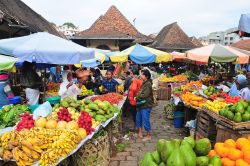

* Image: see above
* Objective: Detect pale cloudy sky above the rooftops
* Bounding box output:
[22,0,250,37]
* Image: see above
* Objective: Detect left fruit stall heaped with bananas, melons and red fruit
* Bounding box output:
[0,93,125,165]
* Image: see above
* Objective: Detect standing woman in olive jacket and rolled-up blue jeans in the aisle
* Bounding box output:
[136,70,154,141]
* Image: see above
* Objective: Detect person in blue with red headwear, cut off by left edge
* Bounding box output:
[0,72,14,109]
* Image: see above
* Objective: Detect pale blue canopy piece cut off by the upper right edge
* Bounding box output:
[238,14,250,37]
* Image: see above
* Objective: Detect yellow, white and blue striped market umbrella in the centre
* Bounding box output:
[110,44,172,64]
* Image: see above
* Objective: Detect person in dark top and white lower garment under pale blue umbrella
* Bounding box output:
[20,62,42,105]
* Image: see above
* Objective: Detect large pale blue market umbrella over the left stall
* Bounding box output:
[0,32,94,65]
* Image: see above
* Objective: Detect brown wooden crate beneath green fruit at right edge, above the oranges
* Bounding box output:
[216,124,250,142]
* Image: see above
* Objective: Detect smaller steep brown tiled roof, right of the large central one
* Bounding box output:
[151,22,196,50]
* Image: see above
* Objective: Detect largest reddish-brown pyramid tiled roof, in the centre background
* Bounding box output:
[76,6,151,41]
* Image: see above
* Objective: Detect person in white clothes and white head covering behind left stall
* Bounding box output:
[58,71,79,99]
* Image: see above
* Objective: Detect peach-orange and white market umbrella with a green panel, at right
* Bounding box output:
[186,44,249,63]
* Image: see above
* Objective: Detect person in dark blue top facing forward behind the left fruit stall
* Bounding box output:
[102,70,119,93]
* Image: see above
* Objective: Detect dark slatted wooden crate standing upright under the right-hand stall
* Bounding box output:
[196,110,217,143]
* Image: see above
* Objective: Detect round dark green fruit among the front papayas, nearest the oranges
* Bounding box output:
[194,138,211,156]
